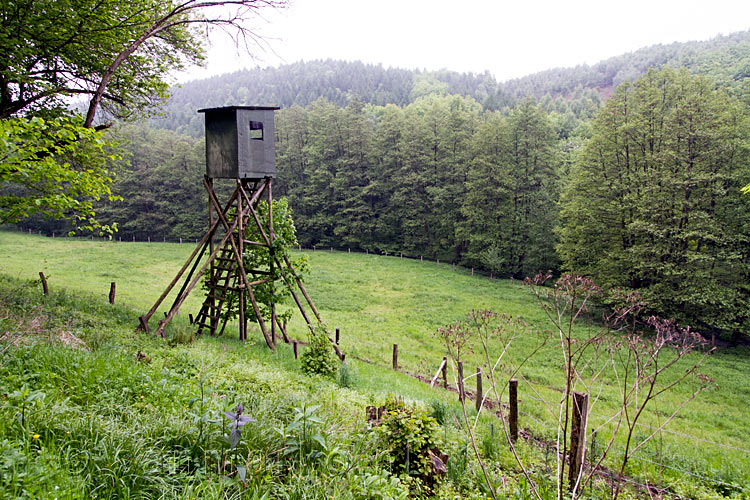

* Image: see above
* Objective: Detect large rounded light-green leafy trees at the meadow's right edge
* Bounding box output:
[559,66,750,331]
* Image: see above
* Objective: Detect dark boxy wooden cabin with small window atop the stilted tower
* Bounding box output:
[198,106,279,179]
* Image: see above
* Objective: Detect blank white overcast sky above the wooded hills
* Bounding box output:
[175,0,750,82]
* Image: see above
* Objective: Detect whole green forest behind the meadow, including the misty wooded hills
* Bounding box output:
[16,32,750,341]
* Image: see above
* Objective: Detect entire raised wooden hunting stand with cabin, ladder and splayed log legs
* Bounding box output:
[139,106,343,359]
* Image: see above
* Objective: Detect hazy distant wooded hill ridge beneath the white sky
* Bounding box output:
[151,31,750,137]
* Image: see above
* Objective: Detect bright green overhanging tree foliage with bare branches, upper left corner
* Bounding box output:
[0,0,285,228]
